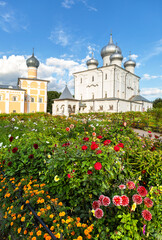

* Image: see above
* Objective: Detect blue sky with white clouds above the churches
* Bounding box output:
[0,0,162,100]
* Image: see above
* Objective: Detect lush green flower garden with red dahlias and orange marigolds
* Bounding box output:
[0,113,162,240]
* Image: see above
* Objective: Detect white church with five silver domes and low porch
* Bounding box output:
[52,34,152,116]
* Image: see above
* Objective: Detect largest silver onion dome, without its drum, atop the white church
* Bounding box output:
[101,34,121,58]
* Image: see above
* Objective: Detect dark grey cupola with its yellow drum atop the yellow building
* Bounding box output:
[26,50,39,78]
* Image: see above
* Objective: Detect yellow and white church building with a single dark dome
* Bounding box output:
[0,53,49,113]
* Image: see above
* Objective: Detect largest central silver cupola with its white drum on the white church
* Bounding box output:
[101,33,121,66]
